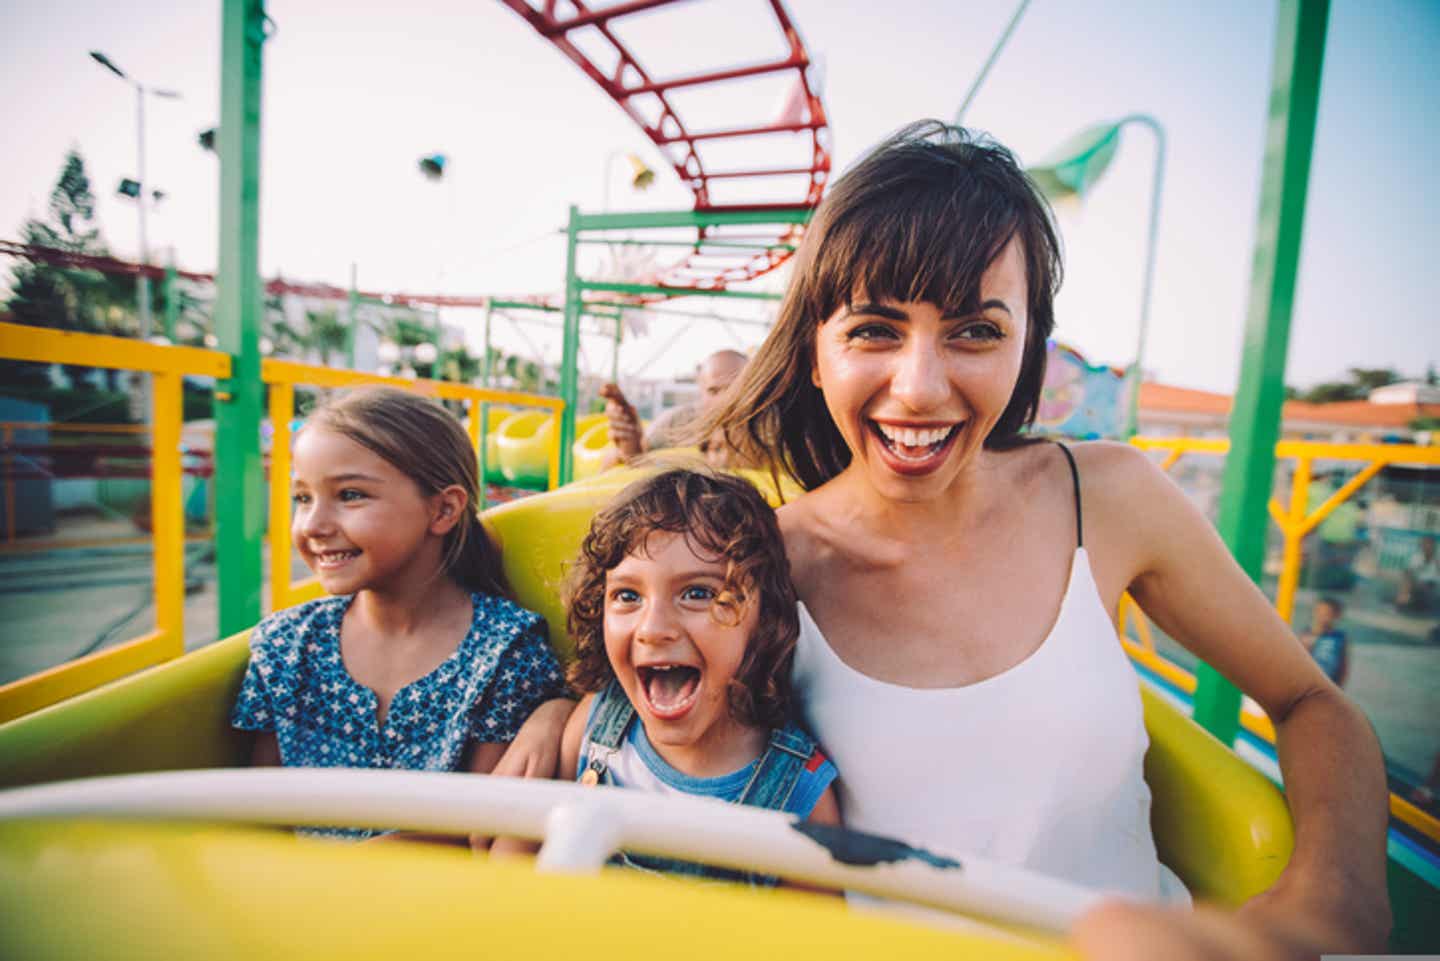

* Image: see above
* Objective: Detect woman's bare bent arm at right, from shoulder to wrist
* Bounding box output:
[1081,445,1391,952]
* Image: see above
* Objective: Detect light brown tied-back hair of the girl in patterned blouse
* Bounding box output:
[307,386,510,598]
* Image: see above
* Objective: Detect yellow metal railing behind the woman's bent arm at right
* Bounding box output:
[1116,437,1440,841]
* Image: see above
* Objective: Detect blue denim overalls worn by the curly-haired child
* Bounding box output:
[585,680,818,888]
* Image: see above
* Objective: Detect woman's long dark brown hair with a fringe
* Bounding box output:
[696,120,1061,490]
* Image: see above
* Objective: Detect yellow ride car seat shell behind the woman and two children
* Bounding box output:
[0,468,1293,905]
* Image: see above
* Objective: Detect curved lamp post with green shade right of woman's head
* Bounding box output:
[1030,114,1165,437]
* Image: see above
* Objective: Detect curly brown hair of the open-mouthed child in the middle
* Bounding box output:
[566,468,799,728]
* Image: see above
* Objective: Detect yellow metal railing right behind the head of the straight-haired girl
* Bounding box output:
[261,360,564,611]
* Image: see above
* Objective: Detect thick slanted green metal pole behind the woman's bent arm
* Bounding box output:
[1195,0,1329,743]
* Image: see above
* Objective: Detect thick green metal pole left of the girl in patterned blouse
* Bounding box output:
[215,0,269,637]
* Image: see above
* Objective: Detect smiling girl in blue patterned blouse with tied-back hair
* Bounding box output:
[232,388,564,844]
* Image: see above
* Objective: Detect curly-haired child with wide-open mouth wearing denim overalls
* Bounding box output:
[560,470,840,886]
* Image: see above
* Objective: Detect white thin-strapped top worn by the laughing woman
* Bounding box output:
[793,547,1187,899]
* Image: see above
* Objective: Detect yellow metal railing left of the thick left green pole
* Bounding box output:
[0,323,230,722]
